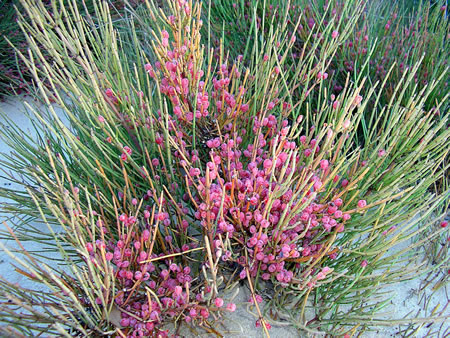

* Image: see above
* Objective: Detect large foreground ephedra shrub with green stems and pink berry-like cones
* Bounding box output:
[0,0,449,337]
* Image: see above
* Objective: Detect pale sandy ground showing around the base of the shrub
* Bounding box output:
[0,97,450,338]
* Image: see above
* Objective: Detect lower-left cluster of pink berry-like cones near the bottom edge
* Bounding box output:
[82,213,236,337]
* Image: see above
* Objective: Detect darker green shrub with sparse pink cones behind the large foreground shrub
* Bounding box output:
[205,0,449,130]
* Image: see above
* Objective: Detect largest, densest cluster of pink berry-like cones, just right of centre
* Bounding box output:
[186,115,356,286]
